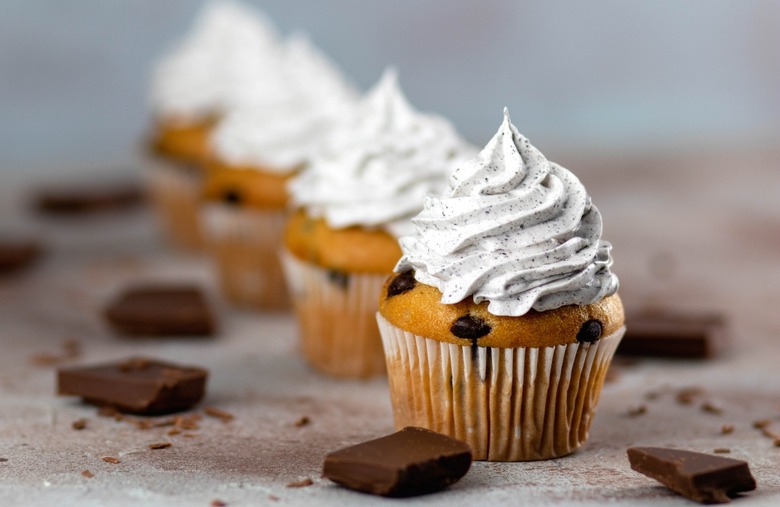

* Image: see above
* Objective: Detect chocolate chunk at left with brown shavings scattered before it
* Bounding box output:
[57,358,208,414]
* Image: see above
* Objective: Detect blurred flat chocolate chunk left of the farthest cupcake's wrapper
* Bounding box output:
[35,180,143,215]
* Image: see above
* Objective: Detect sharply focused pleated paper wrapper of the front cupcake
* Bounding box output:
[377,314,625,461]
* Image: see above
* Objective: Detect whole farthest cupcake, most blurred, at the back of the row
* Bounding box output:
[145,0,279,249]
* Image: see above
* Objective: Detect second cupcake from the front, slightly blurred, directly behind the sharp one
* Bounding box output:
[282,71,473,378]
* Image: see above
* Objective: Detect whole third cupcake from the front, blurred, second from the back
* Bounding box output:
[202,36,358,310]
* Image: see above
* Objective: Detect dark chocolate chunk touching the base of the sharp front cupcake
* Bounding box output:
[322,426,471,497]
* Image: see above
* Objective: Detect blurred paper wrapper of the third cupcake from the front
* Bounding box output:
[201,203,290,310]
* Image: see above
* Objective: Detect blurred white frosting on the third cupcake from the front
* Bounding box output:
[212,36,358,172]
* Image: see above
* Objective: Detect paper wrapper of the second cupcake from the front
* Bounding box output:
[282,251,390,378]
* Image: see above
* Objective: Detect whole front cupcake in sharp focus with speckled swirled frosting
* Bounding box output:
[377,110,625,461]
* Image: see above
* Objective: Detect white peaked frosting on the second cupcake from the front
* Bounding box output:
[290,70,476,236]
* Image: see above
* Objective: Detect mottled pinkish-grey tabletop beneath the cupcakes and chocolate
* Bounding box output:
[0,154,780,506]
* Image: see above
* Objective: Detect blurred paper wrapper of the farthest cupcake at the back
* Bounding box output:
[144,155,204,250]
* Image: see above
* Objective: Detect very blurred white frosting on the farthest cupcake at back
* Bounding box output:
[151,0,280,121]
